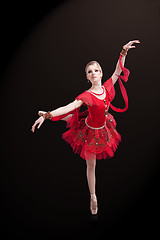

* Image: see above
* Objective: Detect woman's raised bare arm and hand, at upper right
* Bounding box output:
[111,40,140,84]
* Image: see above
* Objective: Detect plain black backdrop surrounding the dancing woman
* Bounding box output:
[0,0,160,239]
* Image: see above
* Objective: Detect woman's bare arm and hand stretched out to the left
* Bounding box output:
[31,99,83,132]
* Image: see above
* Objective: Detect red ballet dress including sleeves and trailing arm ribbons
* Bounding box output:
[51,55,130,160]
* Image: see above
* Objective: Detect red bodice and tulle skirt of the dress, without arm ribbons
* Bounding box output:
[63,88,121,160]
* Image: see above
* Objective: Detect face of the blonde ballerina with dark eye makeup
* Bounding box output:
[86,64,102,83]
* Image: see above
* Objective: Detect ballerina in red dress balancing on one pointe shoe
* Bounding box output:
[31,40,140,215]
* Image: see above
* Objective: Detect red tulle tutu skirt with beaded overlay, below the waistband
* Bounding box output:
[62,113,121,160]
